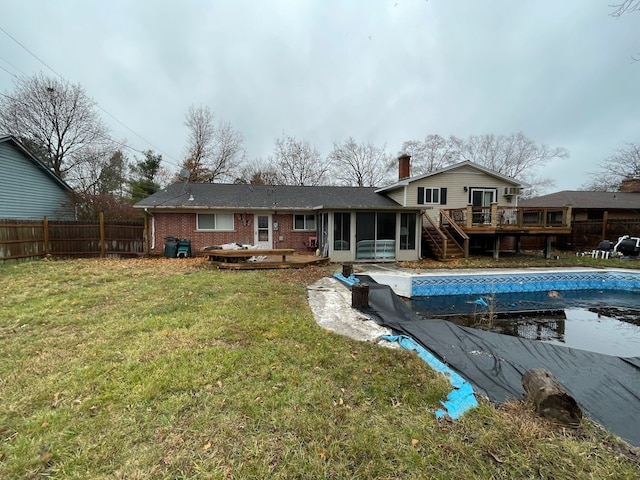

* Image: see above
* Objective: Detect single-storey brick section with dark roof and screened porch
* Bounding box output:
[135,183,420,261]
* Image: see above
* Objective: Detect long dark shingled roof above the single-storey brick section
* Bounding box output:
[134,183,402,210]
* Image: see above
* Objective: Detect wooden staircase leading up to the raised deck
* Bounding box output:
[422,210,469,261]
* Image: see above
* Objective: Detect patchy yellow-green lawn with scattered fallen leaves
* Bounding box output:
[0,259,640,479]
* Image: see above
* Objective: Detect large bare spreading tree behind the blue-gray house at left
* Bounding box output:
[0,73,116,182]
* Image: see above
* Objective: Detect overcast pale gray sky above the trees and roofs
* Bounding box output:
[0,0,640,190]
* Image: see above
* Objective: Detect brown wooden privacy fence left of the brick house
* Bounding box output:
[0,215,145,260]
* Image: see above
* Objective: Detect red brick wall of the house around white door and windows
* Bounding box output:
[148,213,316,255]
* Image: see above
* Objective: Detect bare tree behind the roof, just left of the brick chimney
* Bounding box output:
[329,137,391,187]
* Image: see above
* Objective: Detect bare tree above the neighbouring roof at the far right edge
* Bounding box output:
[582,143,640,192]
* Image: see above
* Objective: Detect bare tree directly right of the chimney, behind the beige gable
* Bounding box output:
[402,135,462,175]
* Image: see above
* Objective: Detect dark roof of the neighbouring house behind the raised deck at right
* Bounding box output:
[518,190,640,210]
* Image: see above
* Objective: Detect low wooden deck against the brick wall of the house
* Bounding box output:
[200,248,329,270]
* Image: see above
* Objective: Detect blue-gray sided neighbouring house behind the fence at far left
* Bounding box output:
[0,135,74,220]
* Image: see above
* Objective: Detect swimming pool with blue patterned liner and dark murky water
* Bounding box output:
[368,268,640,356]
